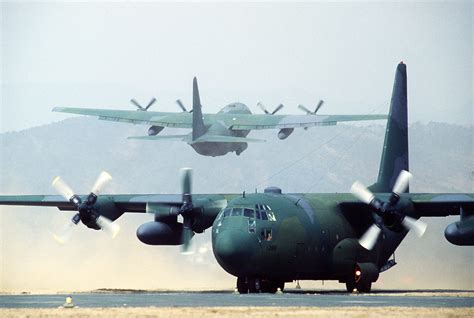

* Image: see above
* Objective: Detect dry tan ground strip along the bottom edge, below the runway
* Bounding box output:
[0,307,474,318]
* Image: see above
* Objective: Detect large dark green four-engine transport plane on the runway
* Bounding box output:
[0,63,474,293]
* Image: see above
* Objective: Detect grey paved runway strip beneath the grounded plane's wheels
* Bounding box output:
[0,291,474,308]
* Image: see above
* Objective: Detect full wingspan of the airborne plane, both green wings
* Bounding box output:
[53,107,387,131]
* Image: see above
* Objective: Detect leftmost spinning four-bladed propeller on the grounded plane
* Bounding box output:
[52,171,120,243]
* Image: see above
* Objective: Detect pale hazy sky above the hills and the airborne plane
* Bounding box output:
[0,1,473,132]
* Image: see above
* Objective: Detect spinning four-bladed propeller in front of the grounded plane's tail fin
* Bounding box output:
[351,170,426,250]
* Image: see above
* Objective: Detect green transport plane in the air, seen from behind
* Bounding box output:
[53,78,387,157]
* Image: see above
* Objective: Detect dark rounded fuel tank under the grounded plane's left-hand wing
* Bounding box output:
[137,221,183,245]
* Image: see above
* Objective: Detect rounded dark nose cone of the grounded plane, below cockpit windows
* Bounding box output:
[213,230,254,272]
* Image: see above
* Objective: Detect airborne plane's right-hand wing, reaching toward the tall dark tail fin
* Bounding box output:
[224,114,387,130]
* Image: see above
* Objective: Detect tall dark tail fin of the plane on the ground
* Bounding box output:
[370,62,409,192]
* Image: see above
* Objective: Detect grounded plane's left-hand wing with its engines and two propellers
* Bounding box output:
[0,169,237,250]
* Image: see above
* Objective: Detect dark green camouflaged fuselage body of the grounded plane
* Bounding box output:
[212,193,407,281]
